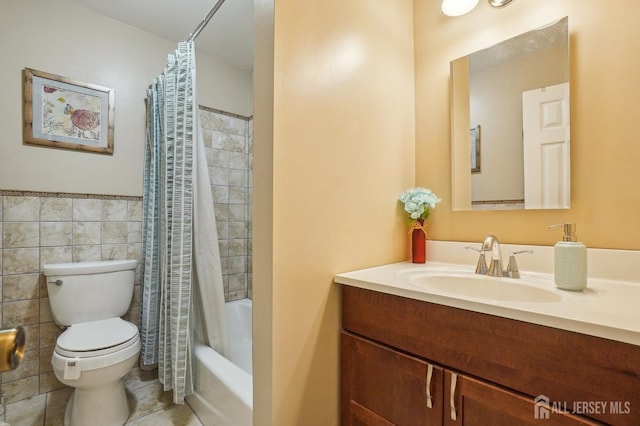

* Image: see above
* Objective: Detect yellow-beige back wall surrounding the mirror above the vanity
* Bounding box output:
[414,0,640,249]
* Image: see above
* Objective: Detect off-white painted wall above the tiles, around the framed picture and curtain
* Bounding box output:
[0,0,252,195]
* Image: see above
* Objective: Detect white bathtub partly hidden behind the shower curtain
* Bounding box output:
[186,299,253,426]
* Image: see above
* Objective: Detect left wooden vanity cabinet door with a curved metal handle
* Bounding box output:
[341,332,443,426]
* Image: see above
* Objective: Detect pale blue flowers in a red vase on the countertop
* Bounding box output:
[399,187,442,263]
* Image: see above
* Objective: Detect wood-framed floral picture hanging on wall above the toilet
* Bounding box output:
[22,68,115,154]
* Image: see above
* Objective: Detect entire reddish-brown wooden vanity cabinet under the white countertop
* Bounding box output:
[341,286,640,426]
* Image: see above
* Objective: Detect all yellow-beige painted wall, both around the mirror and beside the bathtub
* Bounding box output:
[254,0,640,425]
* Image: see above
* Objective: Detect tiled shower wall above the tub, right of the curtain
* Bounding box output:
[200,106,253,301]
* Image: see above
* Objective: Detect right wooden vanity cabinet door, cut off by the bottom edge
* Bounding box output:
[444,370,601,426]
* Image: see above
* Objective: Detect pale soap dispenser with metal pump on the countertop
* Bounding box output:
[549,223,587,291]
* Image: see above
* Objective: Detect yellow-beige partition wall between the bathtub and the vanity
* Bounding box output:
[254,0,414,426]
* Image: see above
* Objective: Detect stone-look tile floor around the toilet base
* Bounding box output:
[7,368,202,426]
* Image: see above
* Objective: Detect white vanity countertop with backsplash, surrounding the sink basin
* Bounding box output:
[334,241,640,346]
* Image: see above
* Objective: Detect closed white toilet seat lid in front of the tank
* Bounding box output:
[57,318,138,353]
